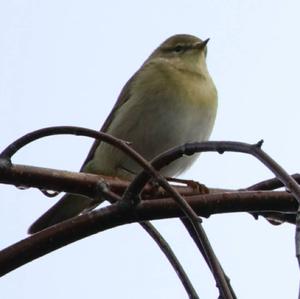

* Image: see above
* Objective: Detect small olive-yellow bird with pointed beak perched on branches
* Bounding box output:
[28,34,217,234]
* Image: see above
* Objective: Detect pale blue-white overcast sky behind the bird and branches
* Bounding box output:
[0,0,300,299]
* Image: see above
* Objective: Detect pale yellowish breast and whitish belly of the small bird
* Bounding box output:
[89,60,217,178]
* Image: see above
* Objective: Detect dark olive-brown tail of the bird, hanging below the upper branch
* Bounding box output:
[28,194,92,234]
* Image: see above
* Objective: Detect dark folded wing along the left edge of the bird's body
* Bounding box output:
[80,73,137,171]
